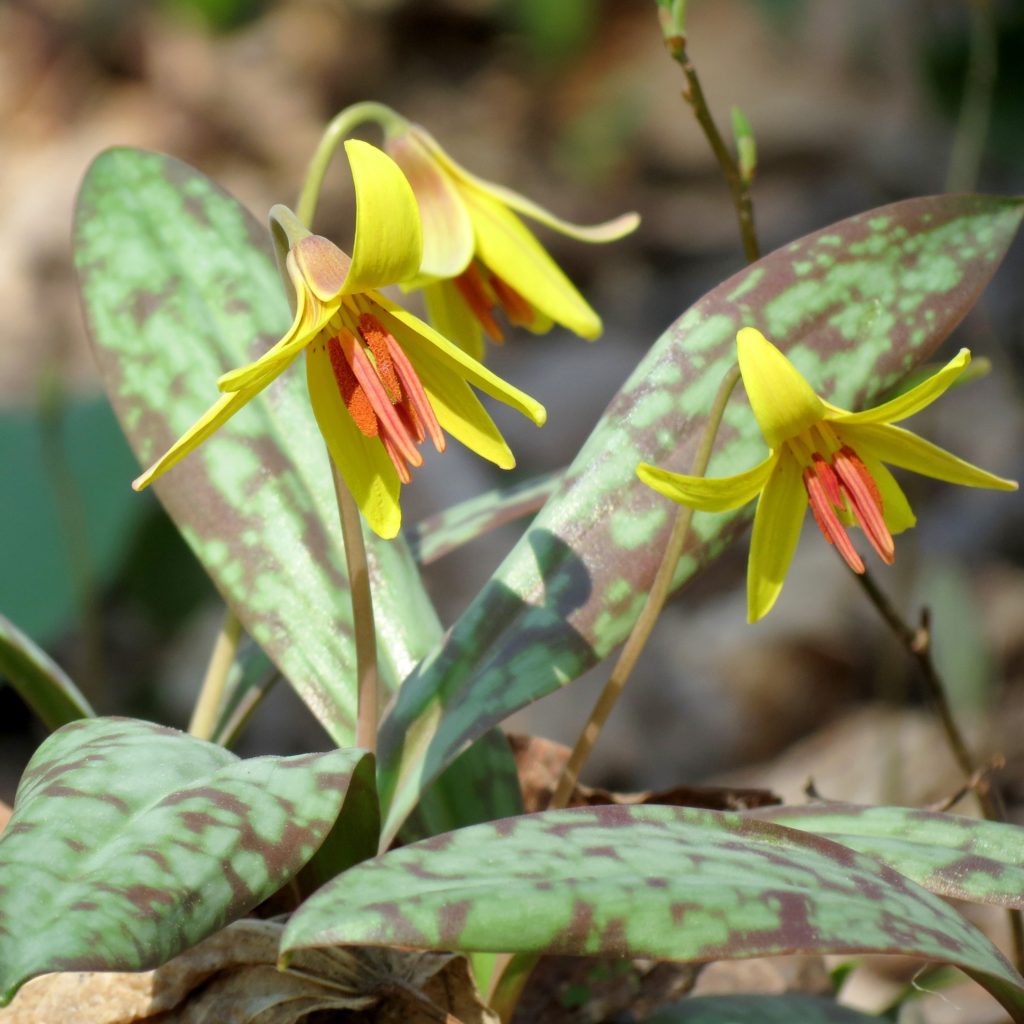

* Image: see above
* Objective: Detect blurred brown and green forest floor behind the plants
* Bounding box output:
[0,0,1024,804]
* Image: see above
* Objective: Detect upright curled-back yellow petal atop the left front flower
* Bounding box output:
[344,138,423,295]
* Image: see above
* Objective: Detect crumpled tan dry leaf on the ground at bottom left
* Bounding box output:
[0,920,497,1024]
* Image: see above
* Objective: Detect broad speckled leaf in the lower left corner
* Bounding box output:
[0,718,374,1005]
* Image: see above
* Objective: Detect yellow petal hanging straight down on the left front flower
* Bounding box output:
[306,344,401,540]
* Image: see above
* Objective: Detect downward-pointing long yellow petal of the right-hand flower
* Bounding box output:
[746,453,807,623]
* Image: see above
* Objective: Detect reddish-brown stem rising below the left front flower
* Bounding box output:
[328,455,379,753]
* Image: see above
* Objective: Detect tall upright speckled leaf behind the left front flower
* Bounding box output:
[75,148,440,746]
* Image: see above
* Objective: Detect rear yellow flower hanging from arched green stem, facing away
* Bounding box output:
[381,111,639,358]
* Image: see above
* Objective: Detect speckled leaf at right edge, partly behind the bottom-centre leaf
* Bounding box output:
[745,804,1024,909]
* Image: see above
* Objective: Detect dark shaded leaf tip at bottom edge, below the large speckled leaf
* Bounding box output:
[645,992,882,1024]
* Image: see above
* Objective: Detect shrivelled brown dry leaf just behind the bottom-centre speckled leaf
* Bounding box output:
[508,735,781,813]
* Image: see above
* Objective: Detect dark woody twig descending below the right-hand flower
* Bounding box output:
[853,569,1024,971]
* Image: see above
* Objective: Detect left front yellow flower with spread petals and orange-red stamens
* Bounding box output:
[132,140,546,538]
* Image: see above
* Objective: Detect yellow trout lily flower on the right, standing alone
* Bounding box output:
[637,328,1017,623]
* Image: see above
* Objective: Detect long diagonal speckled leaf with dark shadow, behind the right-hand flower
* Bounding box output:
[380,196,1024,835]
